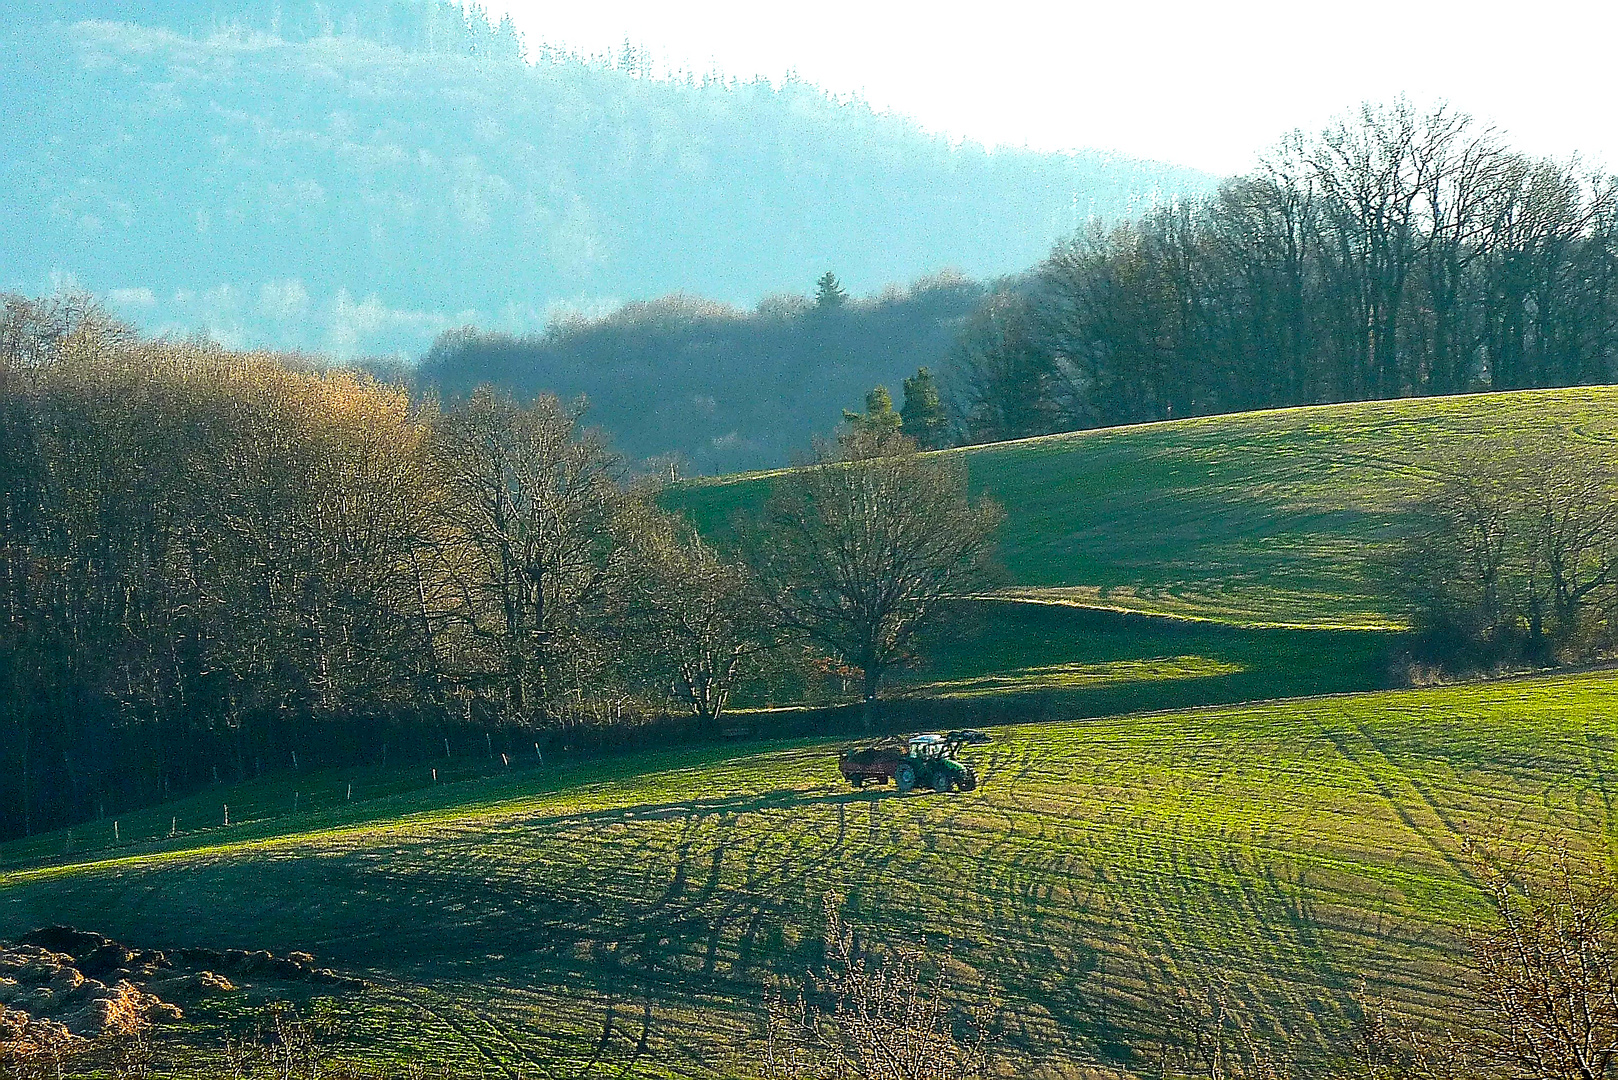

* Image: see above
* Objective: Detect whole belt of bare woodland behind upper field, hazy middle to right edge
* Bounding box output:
[419,102,1618,473]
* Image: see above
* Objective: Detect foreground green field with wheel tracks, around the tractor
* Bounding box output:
[0,672,1618,1077]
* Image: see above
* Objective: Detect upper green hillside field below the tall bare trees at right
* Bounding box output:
[670,387,1618,628]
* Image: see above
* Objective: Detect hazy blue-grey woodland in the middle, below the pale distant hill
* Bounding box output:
[414,275,985,474]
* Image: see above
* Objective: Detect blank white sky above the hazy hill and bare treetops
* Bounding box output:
[482,0,1618,173]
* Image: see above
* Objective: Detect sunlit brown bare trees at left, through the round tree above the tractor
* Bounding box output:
[0,296,998,834]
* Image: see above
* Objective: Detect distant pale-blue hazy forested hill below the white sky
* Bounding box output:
[0,0,1209,363]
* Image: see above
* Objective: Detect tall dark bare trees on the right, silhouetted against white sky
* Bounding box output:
[948,100,1618,442]
